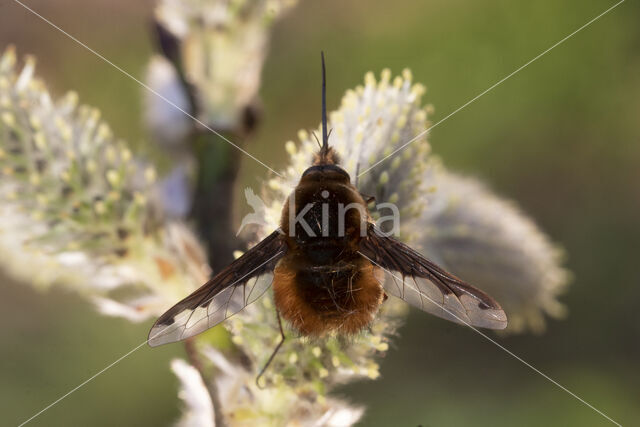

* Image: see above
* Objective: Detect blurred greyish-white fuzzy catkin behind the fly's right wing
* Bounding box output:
[411,170,570,333]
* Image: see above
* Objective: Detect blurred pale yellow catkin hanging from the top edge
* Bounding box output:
[155,0,297,129]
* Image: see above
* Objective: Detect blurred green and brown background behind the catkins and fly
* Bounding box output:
[0,0,640,426]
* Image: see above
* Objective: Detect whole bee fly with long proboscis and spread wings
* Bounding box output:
[149,55,507,371]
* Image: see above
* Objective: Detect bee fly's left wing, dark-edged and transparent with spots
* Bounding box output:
[148,230,286,347]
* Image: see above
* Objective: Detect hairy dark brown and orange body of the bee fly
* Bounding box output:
[273,164,384,336]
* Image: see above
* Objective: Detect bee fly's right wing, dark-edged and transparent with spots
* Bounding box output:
[360,226,507,329]
